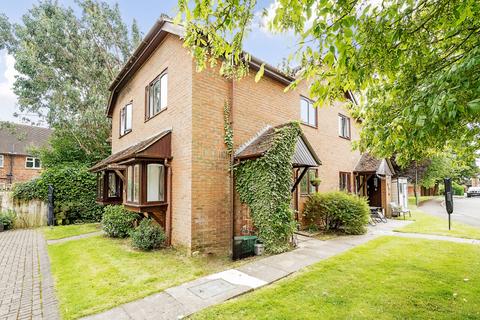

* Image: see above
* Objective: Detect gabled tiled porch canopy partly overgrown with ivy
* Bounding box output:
[234,123,322,192]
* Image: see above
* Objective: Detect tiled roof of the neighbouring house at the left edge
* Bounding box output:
[0,123,52,155]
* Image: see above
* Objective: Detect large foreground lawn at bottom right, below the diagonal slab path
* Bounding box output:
[192,237,480,320]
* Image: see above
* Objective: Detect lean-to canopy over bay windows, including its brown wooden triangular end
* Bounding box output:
[90,129,172,172]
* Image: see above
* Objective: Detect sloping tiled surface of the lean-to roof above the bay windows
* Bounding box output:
[90,129,172,172]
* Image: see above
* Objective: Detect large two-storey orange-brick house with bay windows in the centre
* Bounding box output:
[91,19,394,252]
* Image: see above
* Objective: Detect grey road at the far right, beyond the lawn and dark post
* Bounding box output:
[420,197,480,228]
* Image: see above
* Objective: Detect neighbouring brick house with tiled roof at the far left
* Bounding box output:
[0,123,52,189]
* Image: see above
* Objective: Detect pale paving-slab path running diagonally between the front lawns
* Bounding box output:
[84,220,412,320]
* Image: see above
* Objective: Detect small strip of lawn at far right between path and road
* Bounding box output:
[395,209,480,239]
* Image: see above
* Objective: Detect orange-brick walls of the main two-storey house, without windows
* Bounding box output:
[112,32,360,252]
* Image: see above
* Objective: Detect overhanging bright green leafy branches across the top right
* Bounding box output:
[179,0,480,165]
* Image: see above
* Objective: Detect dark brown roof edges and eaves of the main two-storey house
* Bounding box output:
[107,17,295,116]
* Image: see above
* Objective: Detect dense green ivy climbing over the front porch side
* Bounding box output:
[234,122,301,253]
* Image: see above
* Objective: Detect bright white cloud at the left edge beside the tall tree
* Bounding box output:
[0,50,19,122]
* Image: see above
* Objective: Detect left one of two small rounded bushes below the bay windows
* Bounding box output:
[102,206,138,238]
